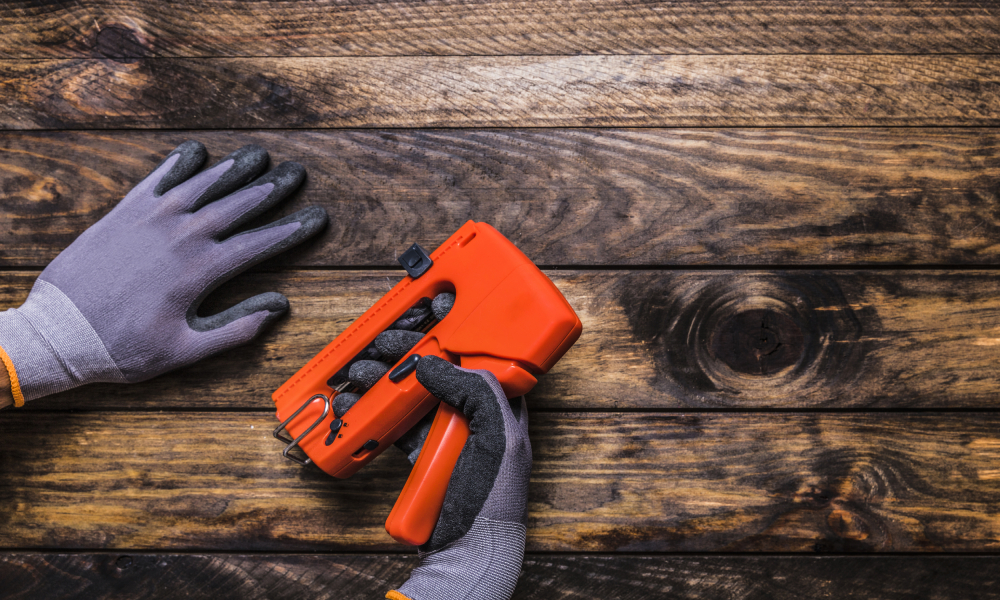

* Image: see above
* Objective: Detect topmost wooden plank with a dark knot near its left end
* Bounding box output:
[0,0,1000,58]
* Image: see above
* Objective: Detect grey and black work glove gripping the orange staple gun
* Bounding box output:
[334,294,531,600]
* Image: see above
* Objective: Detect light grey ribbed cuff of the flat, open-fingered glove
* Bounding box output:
[0,279,125,400]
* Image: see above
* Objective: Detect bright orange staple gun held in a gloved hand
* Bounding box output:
[272,221,582,545]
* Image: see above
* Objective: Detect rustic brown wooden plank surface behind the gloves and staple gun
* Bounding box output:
[0,0,1000,600]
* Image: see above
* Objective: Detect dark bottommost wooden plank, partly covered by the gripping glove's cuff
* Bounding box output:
[0,553,1000,600]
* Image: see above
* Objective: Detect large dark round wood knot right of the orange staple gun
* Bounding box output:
[618,271,878,407]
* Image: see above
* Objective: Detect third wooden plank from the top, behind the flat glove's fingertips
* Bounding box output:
[0,128,1000,267]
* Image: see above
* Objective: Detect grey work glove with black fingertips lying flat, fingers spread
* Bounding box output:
[0,141,327,405]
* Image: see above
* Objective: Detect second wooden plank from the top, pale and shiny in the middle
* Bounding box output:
[0,55,1000,129]
